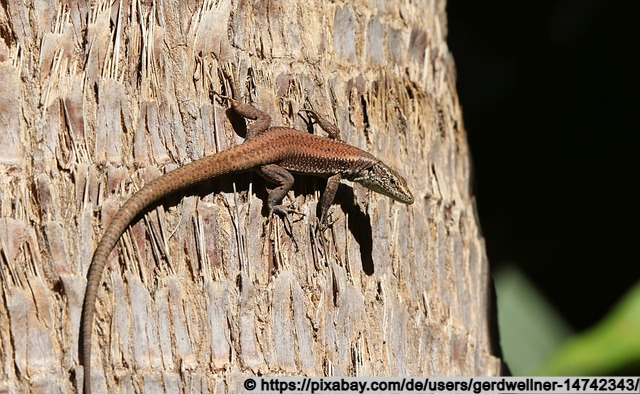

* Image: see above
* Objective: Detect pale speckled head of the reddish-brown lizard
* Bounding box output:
[353,161,414,204]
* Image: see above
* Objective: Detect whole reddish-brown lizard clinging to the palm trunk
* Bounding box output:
[80,70,414,394]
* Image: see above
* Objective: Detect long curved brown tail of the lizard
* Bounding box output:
[80,142,263,394]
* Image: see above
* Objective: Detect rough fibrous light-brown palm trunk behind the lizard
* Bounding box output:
[0,0,499,393]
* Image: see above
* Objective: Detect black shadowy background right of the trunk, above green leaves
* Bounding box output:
[447,0,640,330]
